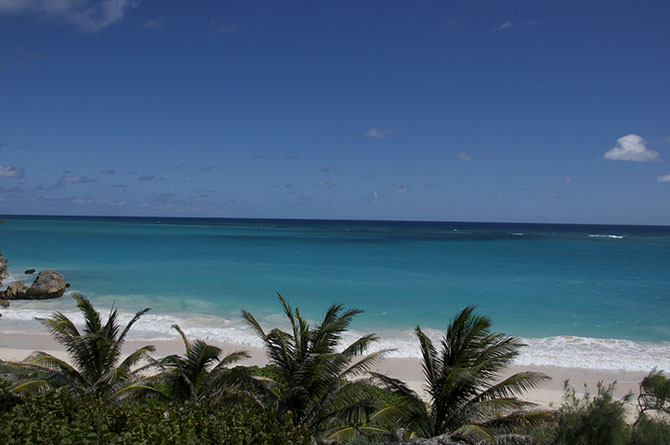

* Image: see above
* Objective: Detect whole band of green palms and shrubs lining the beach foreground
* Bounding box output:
[0,295,670,445]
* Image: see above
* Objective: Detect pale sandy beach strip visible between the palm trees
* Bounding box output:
[0,333,646,419]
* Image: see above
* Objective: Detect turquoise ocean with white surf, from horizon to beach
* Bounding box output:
[0,216,670,371]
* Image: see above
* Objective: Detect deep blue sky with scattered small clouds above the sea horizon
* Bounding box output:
[0,0,670,225]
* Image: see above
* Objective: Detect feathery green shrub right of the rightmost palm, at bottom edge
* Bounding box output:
[552,380,632,445]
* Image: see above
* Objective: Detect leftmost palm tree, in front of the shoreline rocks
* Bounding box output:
[8,295,155,396]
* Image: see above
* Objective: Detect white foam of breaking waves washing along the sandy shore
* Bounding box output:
[0,302,670,372]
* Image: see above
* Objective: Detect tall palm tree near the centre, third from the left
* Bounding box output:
[242,294,385,431]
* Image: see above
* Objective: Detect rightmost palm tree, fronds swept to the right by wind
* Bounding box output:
[371,306,549,440]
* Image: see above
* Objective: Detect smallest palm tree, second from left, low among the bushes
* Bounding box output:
[151,325,249,402]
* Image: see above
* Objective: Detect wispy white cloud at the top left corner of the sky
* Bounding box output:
[0,0,137,32]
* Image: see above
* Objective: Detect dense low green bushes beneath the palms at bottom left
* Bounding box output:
[0,383,311,445]
